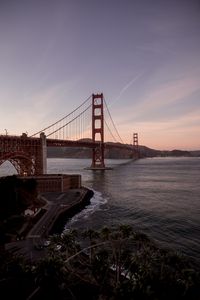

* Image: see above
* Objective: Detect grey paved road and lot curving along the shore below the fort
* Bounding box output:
[5,187,91,260]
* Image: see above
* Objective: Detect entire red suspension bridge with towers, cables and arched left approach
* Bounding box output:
[0,94,139,175]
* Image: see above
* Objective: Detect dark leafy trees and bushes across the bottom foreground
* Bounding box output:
[0,225,200,300]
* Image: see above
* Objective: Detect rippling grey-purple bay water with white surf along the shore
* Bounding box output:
[0,157,200,262]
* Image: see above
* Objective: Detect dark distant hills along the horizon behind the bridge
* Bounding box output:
[47,139,200,159]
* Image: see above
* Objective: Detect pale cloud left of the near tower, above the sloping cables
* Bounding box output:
[1,81,78,135]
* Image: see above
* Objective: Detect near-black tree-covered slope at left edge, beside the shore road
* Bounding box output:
[0,175,44,245]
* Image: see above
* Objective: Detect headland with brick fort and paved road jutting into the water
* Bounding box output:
[5,174,93,259]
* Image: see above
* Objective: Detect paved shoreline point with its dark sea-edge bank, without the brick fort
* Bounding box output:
[5,187,94,261]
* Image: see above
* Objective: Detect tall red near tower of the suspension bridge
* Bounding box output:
[91,93,105,169]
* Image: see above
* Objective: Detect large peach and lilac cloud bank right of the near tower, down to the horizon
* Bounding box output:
[114,76,200,149]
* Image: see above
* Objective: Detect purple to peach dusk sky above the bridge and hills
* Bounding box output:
[0,0,200,150]
